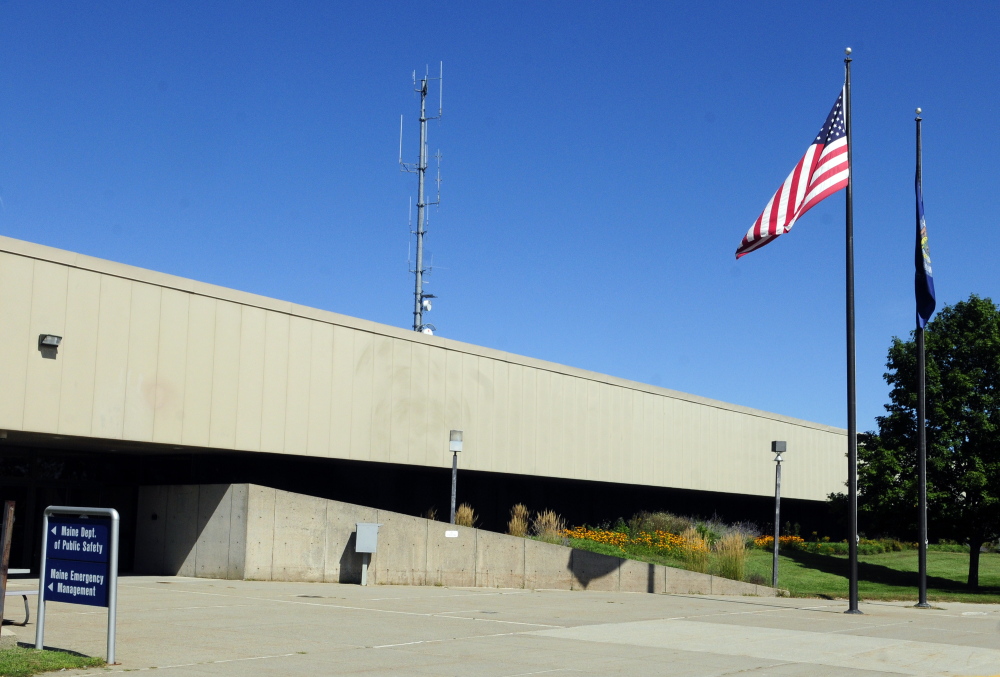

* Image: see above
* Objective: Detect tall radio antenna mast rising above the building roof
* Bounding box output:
[399,62,444,334]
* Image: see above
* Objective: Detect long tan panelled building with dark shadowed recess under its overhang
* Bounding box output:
[0,237,846,568]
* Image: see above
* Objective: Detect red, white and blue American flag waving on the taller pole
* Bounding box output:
[736,89,851,258]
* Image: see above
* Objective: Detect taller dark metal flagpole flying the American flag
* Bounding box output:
[844,47,861,614]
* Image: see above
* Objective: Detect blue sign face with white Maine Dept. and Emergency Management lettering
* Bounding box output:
[42,515,110,606]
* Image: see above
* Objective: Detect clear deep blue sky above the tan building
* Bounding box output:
[0,0,1000,430]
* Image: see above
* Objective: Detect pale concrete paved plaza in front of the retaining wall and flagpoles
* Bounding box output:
[8,577,1000,677]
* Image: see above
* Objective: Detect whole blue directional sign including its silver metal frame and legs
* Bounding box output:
[35,505,119,665]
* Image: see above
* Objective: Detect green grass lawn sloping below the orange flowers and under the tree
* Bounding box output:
[570,539,1000,603]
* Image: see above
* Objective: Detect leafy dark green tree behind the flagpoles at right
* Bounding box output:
[858,294,1000,588]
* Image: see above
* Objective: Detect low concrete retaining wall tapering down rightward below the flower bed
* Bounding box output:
[135,484,775,596]
